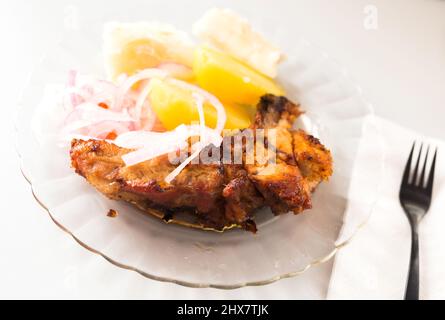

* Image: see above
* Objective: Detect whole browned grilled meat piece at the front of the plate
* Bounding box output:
[71,95,332,232]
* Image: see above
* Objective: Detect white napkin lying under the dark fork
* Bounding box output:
[327,118,445,299]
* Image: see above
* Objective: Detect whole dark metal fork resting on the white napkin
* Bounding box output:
[399,143,437,300]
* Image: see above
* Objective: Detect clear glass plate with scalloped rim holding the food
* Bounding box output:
[13,8,383,289]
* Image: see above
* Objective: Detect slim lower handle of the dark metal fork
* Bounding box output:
[405,221,419,300]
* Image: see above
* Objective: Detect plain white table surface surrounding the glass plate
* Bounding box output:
[0,0,445,299]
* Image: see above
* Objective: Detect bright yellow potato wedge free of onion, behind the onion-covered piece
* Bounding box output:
[193,46,284,106]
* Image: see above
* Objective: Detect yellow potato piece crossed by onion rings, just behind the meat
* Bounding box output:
[150,79,253,130]
